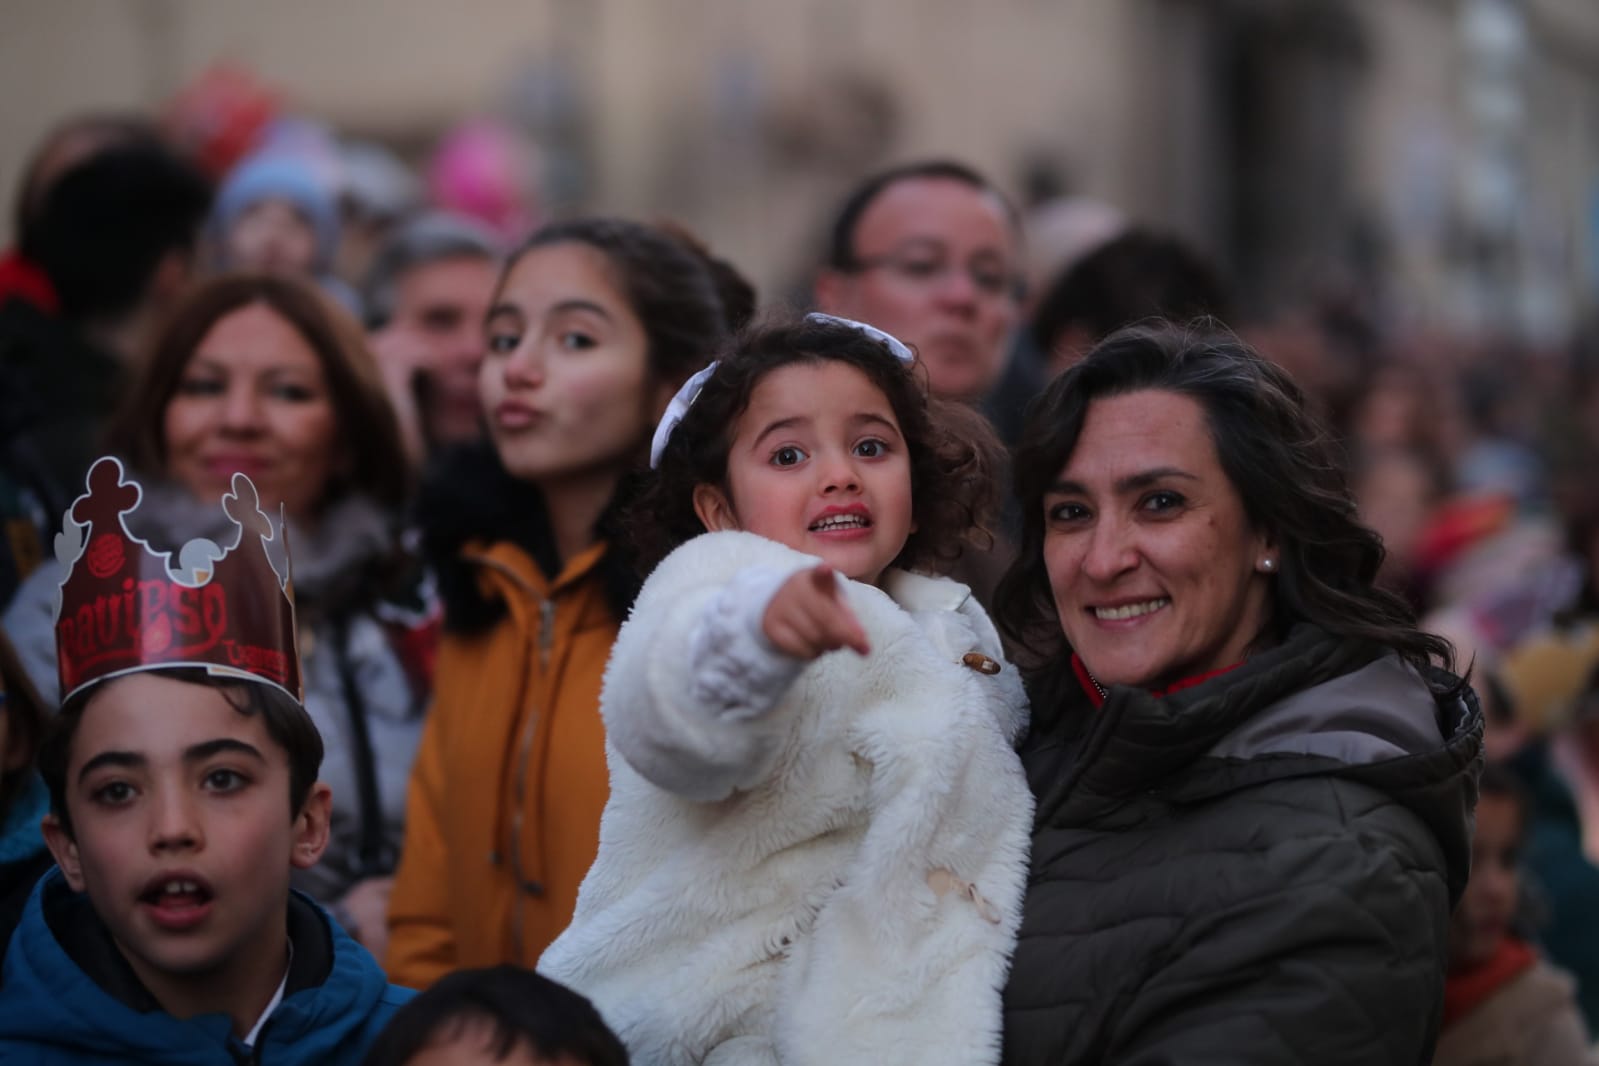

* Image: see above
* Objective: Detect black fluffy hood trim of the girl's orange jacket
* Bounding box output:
[417,441,643,633]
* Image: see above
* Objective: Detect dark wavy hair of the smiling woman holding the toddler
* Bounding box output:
[995,320,1453,694]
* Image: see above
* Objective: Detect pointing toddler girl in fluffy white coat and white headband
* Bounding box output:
[539,315,1031,1066]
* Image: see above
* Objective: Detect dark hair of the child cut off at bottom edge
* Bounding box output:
[365,965,627,1066]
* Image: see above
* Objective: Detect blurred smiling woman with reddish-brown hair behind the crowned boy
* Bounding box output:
[5,273,432,953]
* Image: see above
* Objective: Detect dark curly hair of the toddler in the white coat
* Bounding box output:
[627,316,1003,574]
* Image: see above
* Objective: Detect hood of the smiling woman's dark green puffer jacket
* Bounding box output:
[1035,625,1482,900]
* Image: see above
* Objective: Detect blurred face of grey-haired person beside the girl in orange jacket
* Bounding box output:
[392,256,497,447]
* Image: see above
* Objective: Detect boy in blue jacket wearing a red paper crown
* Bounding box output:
[0,459,411,1066]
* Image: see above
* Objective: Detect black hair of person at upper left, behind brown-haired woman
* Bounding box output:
[21,142,211,321]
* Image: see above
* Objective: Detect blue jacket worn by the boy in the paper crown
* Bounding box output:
[0,869,414,1066]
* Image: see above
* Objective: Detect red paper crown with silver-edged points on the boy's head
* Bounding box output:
[56,457,302,703]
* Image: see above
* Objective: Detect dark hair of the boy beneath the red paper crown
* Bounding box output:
[38,666,323,836]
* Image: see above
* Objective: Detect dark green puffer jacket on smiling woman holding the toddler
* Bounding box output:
[1004,626,1482,1066]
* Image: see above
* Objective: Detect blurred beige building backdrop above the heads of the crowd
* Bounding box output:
[0,0,1599,342]
